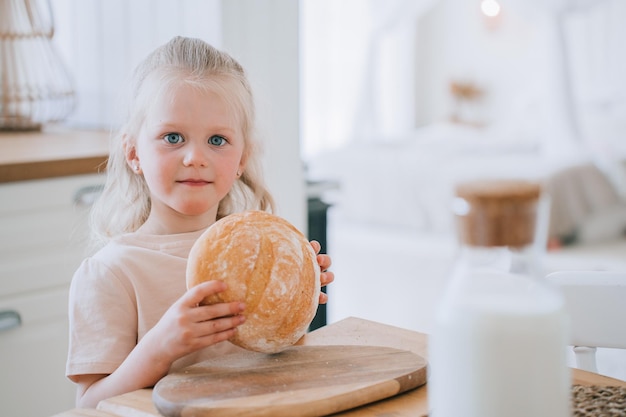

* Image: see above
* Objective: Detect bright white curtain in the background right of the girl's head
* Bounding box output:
[301,0,436,159]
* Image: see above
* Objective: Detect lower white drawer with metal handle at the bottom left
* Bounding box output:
[0,288,76,417]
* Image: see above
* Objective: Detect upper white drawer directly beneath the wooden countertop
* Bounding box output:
[0,174,104,300]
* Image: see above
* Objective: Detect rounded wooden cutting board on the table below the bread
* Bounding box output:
[152,346,426,417]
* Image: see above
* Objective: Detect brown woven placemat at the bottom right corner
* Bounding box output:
[572,385,626,417]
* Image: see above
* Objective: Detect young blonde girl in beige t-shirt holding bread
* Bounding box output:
[66,37,334,407]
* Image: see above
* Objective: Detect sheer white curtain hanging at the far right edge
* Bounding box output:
[524,0,626,192]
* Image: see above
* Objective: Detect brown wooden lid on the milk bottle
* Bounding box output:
[455,180,541,247]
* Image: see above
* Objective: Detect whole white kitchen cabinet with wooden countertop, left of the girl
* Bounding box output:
[0,125,109,417]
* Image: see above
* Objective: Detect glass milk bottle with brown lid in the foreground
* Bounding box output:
[428,180,570,417]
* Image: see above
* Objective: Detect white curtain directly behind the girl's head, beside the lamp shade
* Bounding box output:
[50,0,221,129]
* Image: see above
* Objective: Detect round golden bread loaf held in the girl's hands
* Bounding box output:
[187,211,320,353]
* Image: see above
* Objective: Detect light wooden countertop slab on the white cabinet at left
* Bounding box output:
[0,127,109,183]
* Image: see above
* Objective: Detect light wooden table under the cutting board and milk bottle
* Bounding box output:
[54,318,626,417]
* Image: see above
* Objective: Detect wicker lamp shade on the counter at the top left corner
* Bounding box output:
[0,0,76,130]
